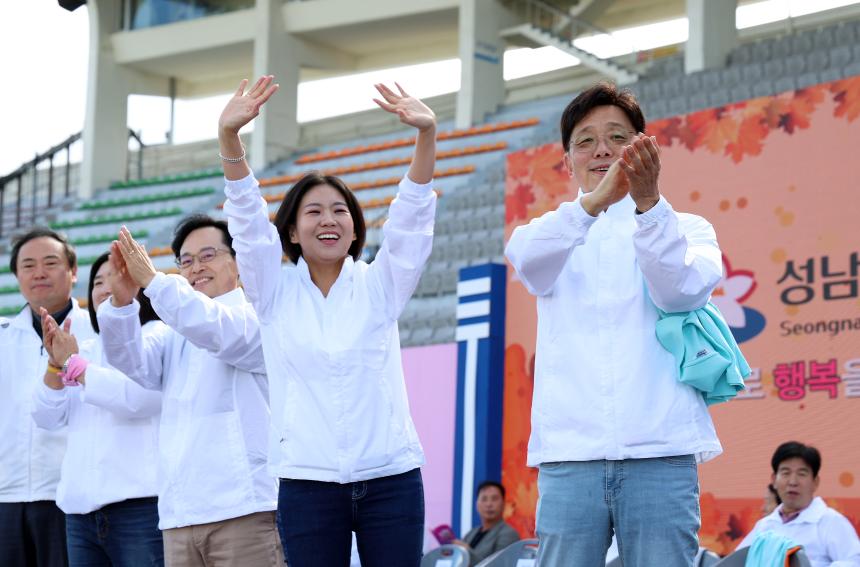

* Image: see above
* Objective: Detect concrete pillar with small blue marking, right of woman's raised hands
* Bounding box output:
[456,0,506,128]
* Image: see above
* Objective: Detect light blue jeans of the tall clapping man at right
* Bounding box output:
[536,455,700,567]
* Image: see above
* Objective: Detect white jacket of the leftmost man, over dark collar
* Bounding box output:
[0,299,95,502]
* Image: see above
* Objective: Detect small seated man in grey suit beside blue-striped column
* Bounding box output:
[452,480,520,565]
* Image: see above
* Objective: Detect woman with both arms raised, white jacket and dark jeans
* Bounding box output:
[219,76,436,567]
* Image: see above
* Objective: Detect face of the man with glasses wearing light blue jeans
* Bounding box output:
[564,105,634,193]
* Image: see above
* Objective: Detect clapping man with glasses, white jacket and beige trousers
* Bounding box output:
[98,215,283,567]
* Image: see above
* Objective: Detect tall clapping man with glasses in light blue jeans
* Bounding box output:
[506,83,722,567]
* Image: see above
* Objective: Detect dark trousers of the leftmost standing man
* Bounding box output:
[0,500,68,567]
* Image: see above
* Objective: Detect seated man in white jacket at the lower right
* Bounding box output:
[738,441,860,567]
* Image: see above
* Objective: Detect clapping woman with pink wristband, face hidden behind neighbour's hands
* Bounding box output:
[32,254,164,567]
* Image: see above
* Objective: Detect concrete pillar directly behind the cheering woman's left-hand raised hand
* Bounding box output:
[248,0,299,171]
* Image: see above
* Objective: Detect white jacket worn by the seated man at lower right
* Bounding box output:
[738,496,860,567]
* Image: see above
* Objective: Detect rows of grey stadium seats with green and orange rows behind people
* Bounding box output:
[0,20,860,338]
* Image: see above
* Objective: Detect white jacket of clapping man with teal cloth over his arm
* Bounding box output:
[505,192,722,466]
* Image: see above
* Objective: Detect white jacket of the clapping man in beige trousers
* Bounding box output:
[98,274,277,529]
